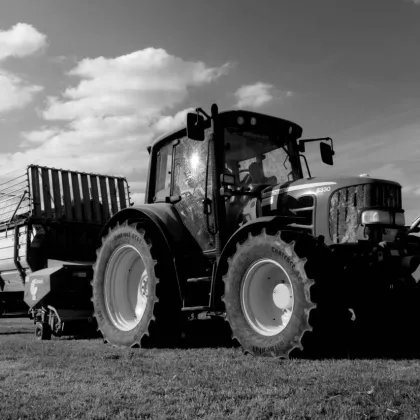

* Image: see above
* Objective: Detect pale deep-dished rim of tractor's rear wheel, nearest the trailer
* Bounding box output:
[105,245,148,331]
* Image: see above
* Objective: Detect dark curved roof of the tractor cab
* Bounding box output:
[150,110,303,152]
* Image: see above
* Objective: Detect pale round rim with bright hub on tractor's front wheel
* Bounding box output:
[240,258,294,336]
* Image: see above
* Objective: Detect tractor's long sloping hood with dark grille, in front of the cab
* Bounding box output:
[261,176,403,243]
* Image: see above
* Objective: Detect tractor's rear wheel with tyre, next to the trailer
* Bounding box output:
[92,222,181,347]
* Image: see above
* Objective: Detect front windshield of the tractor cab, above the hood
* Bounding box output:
[224,128,300,186]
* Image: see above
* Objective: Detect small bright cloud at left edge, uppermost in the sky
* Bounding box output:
[0,23,47,60]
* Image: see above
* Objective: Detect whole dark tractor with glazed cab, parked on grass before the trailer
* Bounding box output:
[92,104,420,358]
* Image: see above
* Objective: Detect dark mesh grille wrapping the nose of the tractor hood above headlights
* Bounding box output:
[329,183,402,244]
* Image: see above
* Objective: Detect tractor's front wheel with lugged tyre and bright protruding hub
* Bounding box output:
[223,230,316,358]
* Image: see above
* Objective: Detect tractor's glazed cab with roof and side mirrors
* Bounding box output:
[146,106,333,255]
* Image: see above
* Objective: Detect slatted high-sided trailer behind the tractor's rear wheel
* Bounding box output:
[0,165,131,339]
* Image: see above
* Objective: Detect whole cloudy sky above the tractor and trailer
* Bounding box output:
[0,0,420,222]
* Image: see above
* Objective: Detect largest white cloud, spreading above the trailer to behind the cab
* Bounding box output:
[0,48,230,200]
